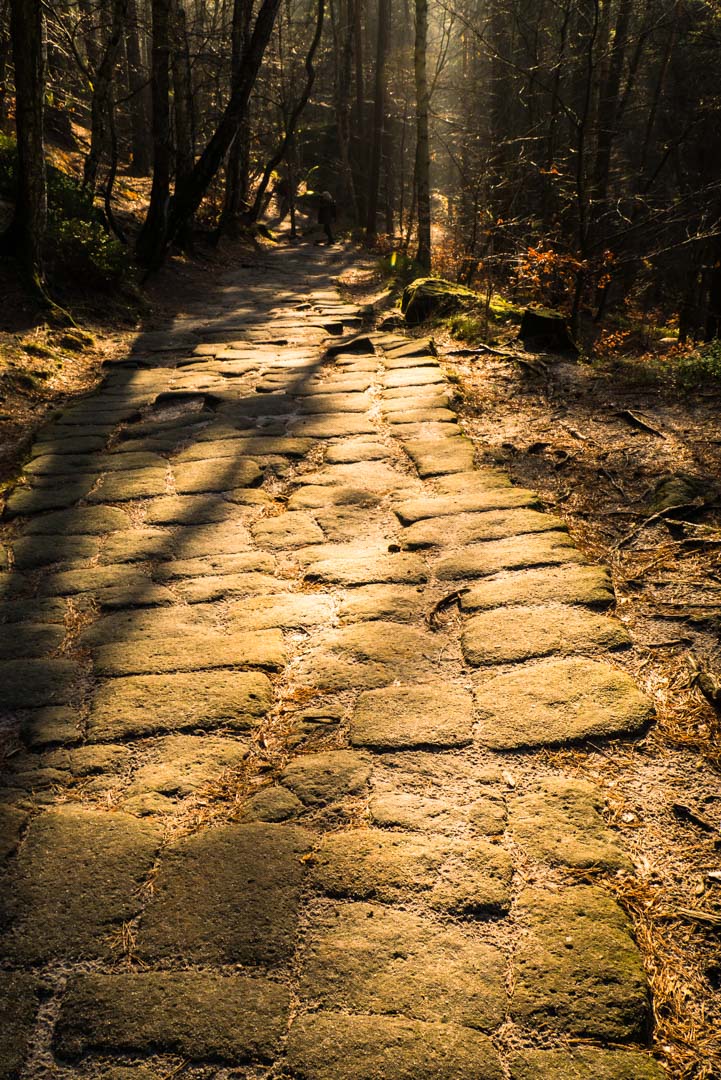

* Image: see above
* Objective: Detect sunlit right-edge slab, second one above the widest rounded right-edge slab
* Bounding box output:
[461,565,614,611]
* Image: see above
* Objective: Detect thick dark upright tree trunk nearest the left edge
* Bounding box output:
[0,0,47,295]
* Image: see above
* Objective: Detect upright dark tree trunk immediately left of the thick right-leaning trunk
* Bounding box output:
[136,0,173,262]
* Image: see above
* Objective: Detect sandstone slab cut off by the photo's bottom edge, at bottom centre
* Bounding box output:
[288,1013,503,1080]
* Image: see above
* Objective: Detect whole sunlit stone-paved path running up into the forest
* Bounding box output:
[0,248,663,1080]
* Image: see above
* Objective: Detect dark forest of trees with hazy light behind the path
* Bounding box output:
[0,0,721,341]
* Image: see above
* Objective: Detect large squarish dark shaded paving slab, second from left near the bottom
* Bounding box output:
[138,824,312,966]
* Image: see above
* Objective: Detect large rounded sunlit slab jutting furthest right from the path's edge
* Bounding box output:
[476,659,653,750]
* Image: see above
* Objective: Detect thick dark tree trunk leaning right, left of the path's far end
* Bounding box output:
[139,0,281,267]
